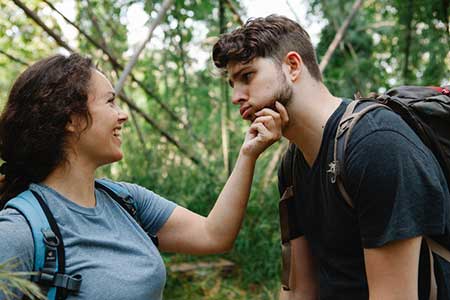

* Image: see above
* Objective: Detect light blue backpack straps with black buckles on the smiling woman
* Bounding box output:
[5,179,158,300]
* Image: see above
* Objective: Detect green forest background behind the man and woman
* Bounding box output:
[0,0,450,300]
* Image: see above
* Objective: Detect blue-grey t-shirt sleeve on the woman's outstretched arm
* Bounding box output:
[120,182,177,235]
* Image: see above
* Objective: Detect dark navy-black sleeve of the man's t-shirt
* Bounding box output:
[346,130,450,248]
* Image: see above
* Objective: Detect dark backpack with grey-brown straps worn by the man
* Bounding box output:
[279,86,450,299]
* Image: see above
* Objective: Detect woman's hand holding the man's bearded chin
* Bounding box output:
[241,101,289,158]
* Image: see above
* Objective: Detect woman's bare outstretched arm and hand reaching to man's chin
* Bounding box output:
[158,103,288,254]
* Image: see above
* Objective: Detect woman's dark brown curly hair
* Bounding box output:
[0,54,94,207]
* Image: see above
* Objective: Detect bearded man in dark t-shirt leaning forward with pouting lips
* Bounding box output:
[213,15,450,300]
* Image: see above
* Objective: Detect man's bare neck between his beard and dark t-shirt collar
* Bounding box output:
[284,82,342,166]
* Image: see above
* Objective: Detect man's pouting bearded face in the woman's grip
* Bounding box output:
[227,57,292,121]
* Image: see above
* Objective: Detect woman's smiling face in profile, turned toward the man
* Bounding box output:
[72,70,128,167]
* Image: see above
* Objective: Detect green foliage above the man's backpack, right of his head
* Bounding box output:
[312,0,450,97]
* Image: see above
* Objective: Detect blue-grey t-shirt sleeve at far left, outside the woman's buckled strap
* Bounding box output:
[0,209,34,272]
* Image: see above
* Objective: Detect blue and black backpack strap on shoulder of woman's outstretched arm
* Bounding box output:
[95,179,159,247]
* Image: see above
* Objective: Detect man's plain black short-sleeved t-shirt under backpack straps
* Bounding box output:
[278,100,450,299]
